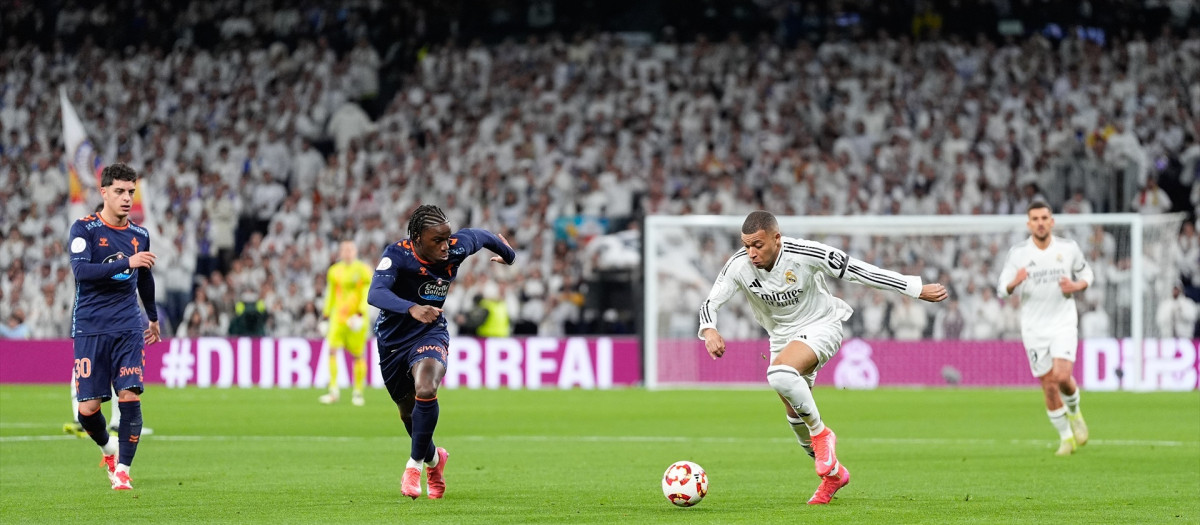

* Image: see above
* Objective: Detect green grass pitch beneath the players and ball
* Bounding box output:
[0,385,1200,524]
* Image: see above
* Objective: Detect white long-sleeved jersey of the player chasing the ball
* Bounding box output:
[697,236,922,339]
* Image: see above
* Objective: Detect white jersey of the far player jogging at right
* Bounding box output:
[996,236,1092,342]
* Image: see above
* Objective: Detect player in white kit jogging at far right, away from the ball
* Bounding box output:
[996,201,1092,455]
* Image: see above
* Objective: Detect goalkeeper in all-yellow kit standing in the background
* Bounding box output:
[320,241,374,406]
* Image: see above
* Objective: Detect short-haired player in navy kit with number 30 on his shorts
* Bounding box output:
[67,164,162,490]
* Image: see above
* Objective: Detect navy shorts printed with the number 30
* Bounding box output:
[74,330,146,402]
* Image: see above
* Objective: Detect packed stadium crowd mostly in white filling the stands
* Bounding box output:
[0,2,1200,339]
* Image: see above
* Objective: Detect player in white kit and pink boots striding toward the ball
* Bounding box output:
[698,211,947,505]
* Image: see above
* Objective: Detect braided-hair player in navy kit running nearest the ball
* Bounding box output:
[367,204,516,500]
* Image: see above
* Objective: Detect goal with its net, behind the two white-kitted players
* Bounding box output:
[642,213,1195,390]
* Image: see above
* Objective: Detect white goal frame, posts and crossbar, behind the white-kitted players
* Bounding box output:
[642,213,1182,390]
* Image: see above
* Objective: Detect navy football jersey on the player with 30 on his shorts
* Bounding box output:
[67,213,157,337]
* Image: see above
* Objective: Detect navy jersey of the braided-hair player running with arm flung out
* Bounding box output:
[367,228,516,348]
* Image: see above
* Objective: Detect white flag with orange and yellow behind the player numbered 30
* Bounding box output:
[59,86,144,222]
